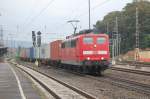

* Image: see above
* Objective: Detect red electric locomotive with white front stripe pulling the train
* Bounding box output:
[61,32,110,73]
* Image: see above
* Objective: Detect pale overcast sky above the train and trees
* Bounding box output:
[0,0,132,42]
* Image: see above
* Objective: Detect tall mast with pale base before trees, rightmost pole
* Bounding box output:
[135,7,139,61]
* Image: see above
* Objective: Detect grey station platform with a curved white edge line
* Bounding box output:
[0,63,43,99]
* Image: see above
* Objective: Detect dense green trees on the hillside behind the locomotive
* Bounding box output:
[94,0,150,53]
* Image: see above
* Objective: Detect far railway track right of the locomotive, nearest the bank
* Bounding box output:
[110,67,150,76]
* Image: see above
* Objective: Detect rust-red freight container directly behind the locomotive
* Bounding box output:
[50,40,62,61]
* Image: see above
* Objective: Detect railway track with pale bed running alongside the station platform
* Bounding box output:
[11,62,96,99]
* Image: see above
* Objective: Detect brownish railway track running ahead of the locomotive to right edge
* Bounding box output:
[86,75,150,95]
